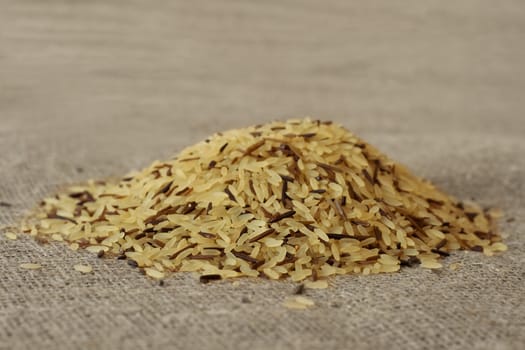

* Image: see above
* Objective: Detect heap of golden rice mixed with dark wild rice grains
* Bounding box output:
[23,119,507,287]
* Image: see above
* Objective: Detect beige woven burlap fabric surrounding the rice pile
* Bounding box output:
[0,0,525,350]
